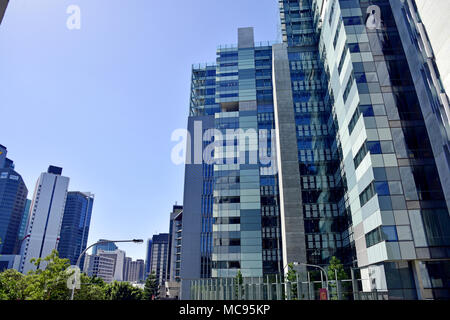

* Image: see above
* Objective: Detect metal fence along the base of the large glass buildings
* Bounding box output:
[190,273,388,300]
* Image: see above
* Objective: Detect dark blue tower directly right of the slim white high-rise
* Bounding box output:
[58,191,94,266]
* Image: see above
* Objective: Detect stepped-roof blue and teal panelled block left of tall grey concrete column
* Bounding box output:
[181,28,283,296]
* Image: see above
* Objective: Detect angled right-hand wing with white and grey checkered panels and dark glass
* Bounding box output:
[300,0,450,299]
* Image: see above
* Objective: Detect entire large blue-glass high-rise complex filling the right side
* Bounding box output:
[181,0,450,299]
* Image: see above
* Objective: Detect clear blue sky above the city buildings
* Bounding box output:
[0,0,279,259]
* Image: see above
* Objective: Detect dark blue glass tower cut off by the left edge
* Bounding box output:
[0,145,28,255]
